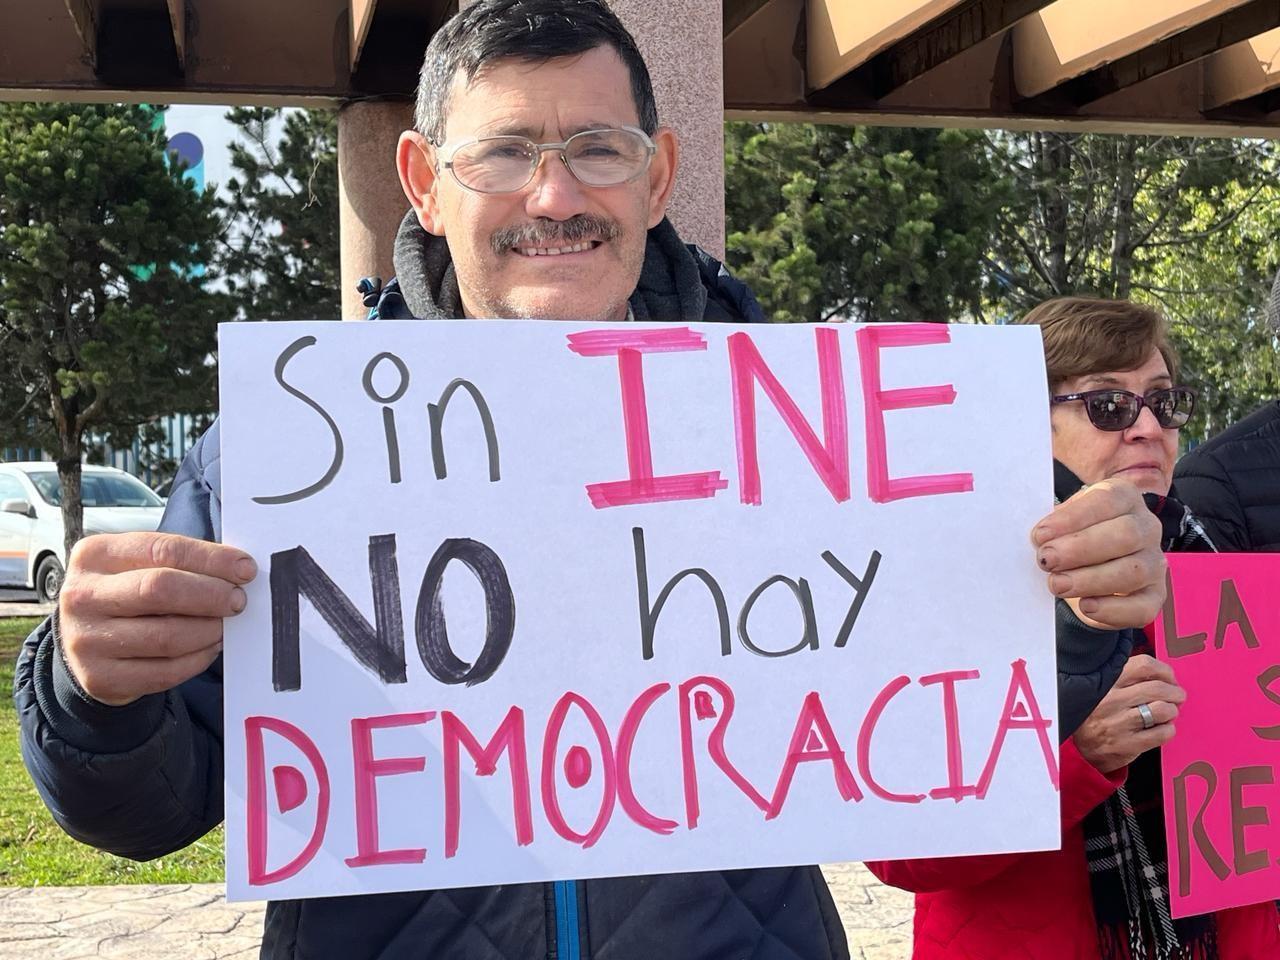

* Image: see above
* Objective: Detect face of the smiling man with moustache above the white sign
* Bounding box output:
[401,46,676,320]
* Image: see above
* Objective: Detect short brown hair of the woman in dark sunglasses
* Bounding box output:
[1015,297,1178,389]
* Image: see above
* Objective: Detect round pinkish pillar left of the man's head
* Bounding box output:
[338,100,413,320]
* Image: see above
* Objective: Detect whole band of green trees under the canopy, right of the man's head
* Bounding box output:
[726,123,1280,448]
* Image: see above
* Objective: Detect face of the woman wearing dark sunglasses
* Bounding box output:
[1051,349,1178,497]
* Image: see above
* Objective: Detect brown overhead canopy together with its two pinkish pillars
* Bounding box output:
[0,0,1280,317]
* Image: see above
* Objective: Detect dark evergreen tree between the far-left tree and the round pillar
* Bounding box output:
[223,106,340,320]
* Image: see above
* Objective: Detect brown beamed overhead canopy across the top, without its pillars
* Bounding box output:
[0,0,1280,133]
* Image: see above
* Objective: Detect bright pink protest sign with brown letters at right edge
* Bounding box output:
[1156,553,1280,916]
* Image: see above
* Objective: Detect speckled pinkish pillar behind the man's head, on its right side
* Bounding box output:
[460,0,724,259]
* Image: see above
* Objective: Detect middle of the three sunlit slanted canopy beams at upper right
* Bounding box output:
[1014,0,1280,105]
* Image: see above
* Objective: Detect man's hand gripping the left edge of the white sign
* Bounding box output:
[58,534,257,707]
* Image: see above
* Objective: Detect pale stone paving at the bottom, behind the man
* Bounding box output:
[0,864,911,960]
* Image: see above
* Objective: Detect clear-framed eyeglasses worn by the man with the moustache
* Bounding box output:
[442,127,658,193]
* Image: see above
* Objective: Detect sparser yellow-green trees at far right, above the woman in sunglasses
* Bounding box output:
[988,133,1280,439]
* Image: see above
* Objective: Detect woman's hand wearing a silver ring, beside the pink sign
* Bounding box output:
[1075,654,1187,773]
